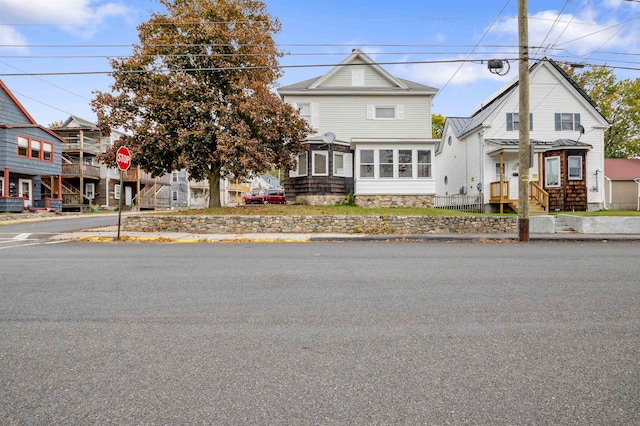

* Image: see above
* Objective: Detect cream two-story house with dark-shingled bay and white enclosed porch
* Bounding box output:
[278,49,439,207]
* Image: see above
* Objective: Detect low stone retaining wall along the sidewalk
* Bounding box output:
[123,215,518,234]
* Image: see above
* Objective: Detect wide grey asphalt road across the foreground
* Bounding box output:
[0,241,640,425]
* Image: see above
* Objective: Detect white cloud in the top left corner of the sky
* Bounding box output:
[2,0,128,36]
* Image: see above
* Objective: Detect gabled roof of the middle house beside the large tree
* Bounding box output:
[278,49,438,95]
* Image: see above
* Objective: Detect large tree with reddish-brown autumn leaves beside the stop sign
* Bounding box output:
[92,0,310,207]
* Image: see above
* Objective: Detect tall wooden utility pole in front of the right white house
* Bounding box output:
[518,0,531,241]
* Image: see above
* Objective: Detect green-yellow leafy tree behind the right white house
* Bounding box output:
[563,62,640,158]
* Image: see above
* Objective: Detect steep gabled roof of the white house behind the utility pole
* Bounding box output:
[447,58,607,137]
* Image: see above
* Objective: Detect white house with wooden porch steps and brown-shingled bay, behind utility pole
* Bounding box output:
[435,59,609,213]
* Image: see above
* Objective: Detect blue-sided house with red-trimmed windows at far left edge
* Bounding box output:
[0,80,63,212]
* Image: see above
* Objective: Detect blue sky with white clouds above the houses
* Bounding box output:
[0,0,640,126]
